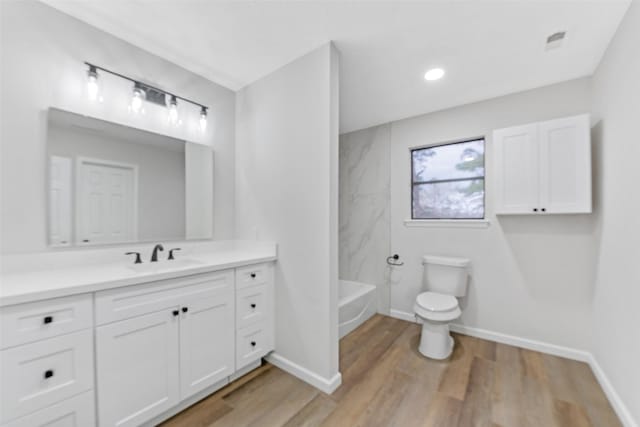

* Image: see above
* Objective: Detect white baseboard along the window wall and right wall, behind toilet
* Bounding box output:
[389,309,640,427]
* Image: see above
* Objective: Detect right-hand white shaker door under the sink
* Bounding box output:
[180,271,235,399]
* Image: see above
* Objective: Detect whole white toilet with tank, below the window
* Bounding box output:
[414,255,470,359]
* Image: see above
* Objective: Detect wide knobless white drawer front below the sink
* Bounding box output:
[96,270,234,325]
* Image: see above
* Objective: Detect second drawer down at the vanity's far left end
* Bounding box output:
[0,329,93,421]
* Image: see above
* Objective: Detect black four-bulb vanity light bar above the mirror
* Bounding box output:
[85,62,209,127]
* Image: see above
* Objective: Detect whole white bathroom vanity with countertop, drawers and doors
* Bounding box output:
[0,245,276,427]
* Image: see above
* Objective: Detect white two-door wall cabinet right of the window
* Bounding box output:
[493,114,591,214]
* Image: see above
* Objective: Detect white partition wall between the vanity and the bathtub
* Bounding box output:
[236,44,339,388]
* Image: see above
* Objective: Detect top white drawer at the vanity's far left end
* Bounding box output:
[0,294,93,348]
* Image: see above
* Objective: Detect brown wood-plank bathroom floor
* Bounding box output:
[163,315,621,427]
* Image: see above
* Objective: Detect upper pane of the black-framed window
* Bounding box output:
[411,139,484,182]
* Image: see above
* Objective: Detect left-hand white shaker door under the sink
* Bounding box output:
[96,307,180,427]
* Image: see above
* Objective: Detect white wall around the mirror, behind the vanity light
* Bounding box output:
[0,0,235,253]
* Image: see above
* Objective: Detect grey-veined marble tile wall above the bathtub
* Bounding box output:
[340,124,391,314]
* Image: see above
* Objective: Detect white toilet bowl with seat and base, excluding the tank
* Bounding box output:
[414,292,462,359]
